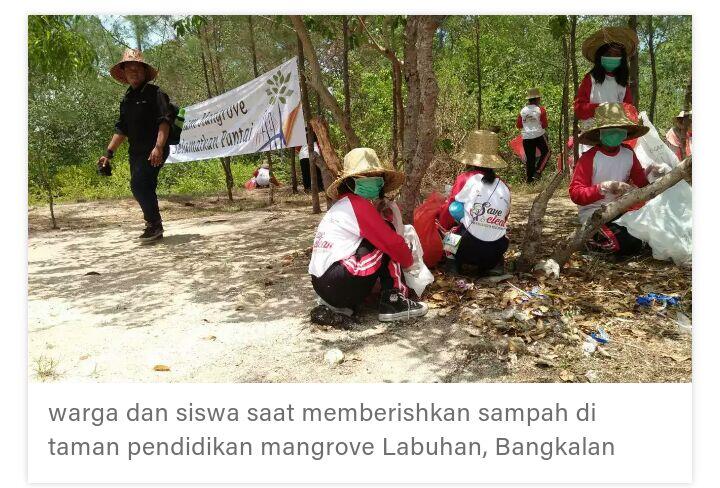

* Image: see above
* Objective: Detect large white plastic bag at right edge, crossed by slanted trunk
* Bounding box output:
[617,112,692,266]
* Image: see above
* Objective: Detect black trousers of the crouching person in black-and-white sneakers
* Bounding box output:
[311,239,408,308]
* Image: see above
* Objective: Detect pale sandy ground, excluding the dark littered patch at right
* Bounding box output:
[28,187,691,382]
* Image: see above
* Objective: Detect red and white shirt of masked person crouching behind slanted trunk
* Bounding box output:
[570,144,648,223]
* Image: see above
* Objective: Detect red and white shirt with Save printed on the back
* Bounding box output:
[440,170,511,242]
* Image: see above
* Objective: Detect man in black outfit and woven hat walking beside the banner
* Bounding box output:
[98,49,173,242]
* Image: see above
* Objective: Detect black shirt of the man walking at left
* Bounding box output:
[115,83,173,161]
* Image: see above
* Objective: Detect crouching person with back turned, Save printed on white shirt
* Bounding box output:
[440,130,511,274]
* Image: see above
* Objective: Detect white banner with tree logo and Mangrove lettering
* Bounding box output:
[167,58,306,163]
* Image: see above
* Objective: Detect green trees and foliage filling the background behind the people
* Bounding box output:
[28,15,692,217]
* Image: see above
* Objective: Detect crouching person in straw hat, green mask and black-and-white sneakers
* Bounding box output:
[309,148,428,321]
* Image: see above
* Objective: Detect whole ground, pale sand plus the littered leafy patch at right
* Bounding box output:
[28,190,692,383]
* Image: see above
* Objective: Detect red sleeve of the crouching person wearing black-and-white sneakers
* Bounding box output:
[350,195,413,268]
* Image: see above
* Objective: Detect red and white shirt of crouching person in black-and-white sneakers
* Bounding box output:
[308,193,413,278]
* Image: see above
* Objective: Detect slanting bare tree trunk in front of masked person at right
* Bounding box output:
[553,156,692,269]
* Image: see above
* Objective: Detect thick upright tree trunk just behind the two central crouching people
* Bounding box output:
[400,15,442,223]
